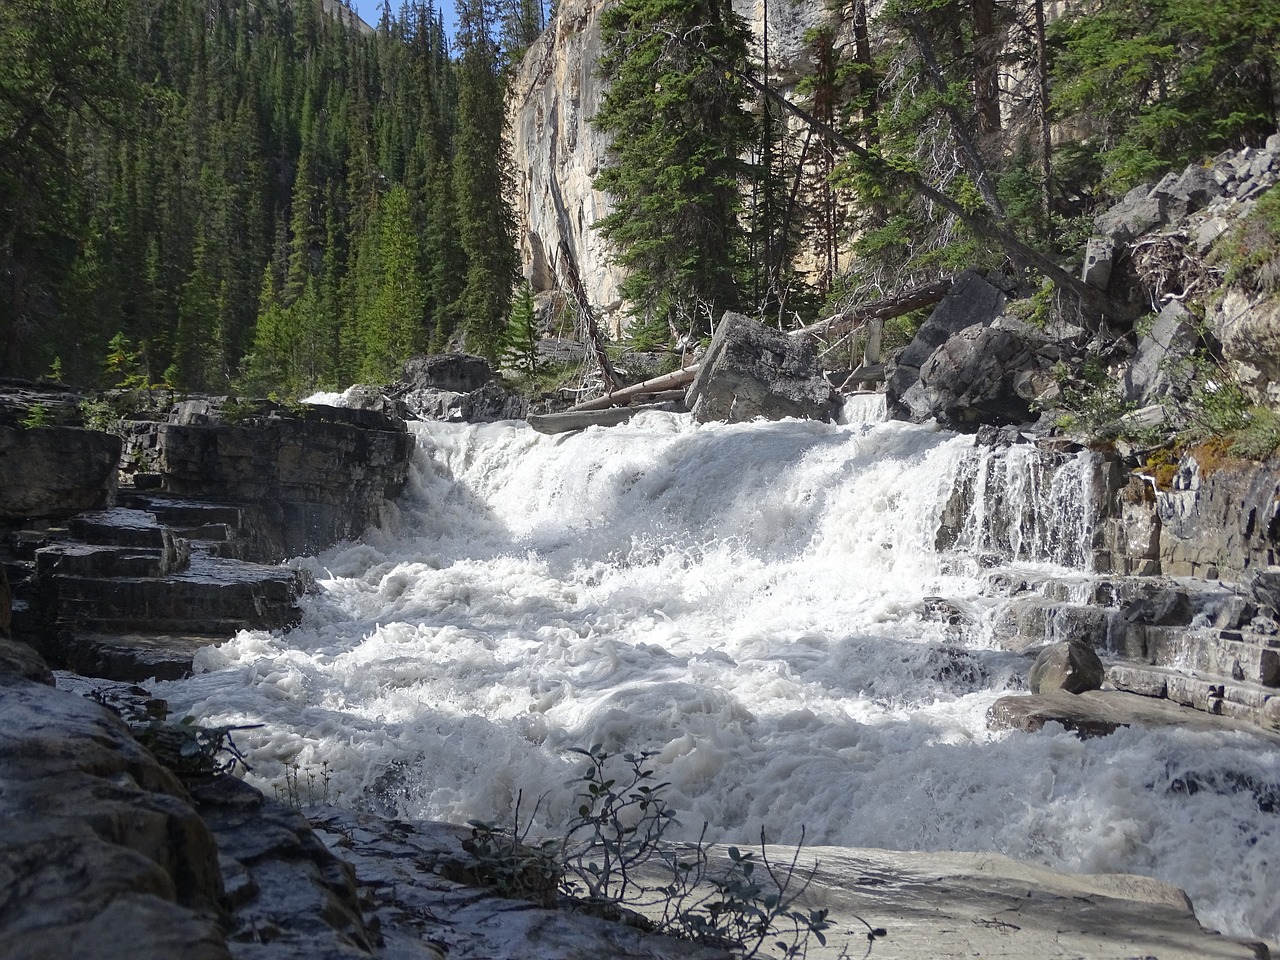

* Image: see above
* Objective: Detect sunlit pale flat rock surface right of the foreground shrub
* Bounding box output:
[793,847,1270,960]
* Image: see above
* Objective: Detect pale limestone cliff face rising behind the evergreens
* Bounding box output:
[509,0,832,323]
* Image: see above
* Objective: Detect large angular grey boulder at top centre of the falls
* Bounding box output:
[685,312,840,422]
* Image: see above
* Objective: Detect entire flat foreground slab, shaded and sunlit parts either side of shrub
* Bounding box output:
[302,808,1268,960]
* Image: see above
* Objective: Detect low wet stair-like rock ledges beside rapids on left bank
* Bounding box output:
[8,486,310,681]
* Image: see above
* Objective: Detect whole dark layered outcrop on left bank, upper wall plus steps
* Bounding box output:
[0,398,412,681]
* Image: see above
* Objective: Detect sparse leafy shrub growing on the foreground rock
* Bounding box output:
[463,745,884,957]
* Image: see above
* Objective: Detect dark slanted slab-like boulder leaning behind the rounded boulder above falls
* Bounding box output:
[884,270,1006,420]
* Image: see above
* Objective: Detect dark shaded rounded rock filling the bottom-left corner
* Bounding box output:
[0,673,229,960]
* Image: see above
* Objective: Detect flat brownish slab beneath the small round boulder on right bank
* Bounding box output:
[987,690,1280,742]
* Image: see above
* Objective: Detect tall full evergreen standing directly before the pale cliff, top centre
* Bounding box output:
[593,0,755,340]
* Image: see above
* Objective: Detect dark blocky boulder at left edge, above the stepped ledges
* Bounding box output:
[0,426,120,524]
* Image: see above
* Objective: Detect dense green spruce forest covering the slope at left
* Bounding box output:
[0,0,543,396]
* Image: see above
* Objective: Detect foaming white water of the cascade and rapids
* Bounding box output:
[157,413,1280,940]
